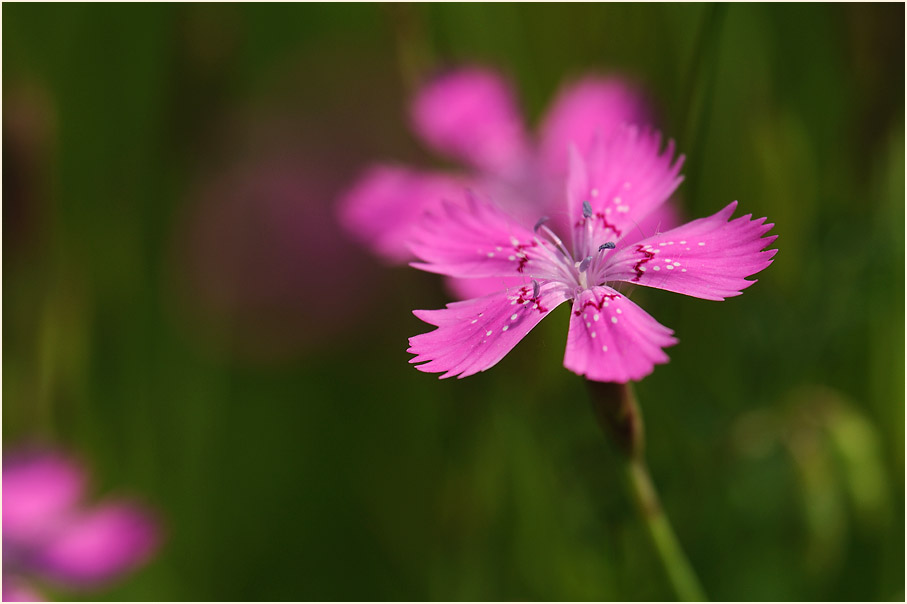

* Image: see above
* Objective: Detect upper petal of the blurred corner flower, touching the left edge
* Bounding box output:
[3,451,86,546]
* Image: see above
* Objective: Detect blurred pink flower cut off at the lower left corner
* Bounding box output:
[3,450,158,601]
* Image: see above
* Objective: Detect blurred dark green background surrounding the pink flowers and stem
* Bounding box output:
[2,4,905,600]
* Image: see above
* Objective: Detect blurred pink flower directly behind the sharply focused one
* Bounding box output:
[340,67,677,297]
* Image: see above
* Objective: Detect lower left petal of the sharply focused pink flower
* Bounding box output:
[407,282,569,378]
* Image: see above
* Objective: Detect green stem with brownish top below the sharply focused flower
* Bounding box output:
[588,382,706,602]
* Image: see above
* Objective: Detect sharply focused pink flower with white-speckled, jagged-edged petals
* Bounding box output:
[409,127,777,383]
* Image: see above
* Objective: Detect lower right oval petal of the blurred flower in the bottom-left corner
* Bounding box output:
[35,502,158,585]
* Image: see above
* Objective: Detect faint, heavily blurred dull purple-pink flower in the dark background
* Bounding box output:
[172,150,370,363]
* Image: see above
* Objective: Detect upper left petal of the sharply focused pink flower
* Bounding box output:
[410,193,560,283]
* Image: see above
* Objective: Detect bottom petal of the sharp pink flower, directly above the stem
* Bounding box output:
[564,286,677,383]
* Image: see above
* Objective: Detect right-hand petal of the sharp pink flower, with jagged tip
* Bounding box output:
[603,201,778,300]
